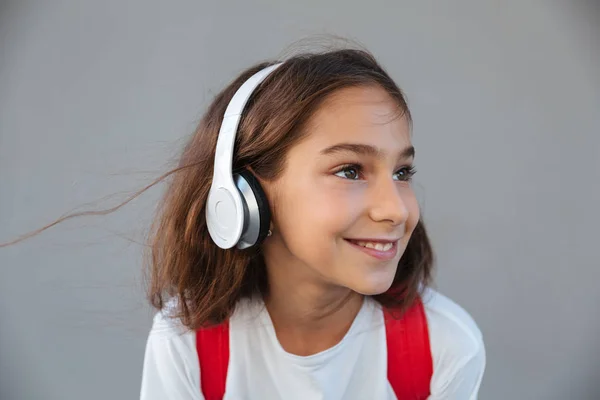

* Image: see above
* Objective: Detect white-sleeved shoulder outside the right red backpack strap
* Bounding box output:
[423,289,486,399]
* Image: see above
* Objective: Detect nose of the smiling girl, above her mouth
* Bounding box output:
[369,179,408,226]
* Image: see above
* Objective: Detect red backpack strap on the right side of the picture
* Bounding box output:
[384,299,433,400]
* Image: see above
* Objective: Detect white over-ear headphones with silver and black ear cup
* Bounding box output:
[206,63,282,249]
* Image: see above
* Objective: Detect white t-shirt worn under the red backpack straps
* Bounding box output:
[140,289,485,400]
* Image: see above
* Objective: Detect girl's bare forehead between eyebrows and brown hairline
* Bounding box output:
[304,86,410,152]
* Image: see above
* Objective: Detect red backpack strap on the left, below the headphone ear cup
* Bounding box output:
[196,321,229,400]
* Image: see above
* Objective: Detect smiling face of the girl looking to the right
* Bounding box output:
[263,87,419,295]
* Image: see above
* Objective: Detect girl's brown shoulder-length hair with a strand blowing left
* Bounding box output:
[0,49,434,329]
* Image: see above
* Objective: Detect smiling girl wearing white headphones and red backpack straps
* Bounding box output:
[140,50,485,400]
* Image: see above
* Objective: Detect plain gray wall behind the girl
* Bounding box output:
[0,0,600,400]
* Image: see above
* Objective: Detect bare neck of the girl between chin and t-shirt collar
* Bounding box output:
[265,247,363,356]
